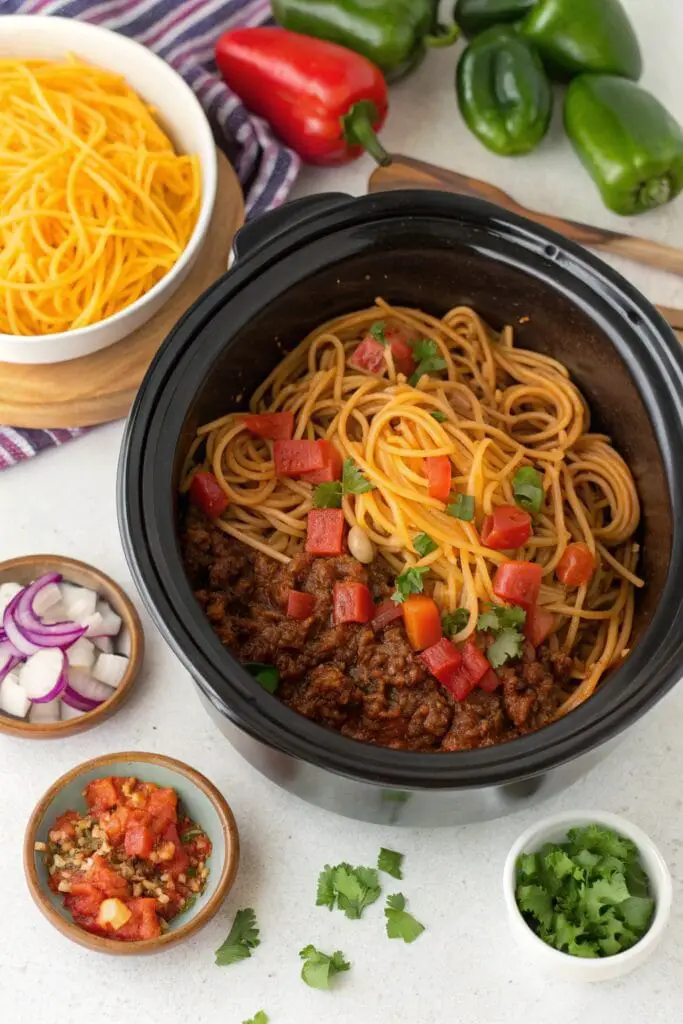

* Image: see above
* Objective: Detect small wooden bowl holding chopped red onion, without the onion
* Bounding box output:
[0,555,144,739]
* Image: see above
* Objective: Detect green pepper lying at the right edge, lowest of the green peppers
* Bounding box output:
[564,75,683,216]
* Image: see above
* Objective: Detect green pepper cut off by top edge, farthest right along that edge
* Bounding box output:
[521,0,643,82]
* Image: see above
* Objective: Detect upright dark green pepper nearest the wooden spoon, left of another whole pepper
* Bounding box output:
[457,25,553,157]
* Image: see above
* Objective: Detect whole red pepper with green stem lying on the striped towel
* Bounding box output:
[216,28,390,165]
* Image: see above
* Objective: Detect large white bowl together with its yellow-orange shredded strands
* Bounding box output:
[0,15,217,364]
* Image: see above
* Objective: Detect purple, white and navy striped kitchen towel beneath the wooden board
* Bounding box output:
[0,0,300,469]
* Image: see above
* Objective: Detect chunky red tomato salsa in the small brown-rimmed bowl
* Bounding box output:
[36,776,211,942]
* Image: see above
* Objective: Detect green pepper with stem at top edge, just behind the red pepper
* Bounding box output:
[272,0,460,82]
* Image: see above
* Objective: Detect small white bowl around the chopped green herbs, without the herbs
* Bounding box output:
[503,809,673,975]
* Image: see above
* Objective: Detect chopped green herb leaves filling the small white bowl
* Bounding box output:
[515,824,654,958]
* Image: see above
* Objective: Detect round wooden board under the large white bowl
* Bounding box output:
[0,153,245,428]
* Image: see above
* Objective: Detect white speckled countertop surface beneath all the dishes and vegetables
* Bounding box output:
[0,0,683,1024]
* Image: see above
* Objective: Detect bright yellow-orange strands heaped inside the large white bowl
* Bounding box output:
[0,57,201,335]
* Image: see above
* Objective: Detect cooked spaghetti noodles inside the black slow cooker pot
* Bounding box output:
[182,299,643,713]
